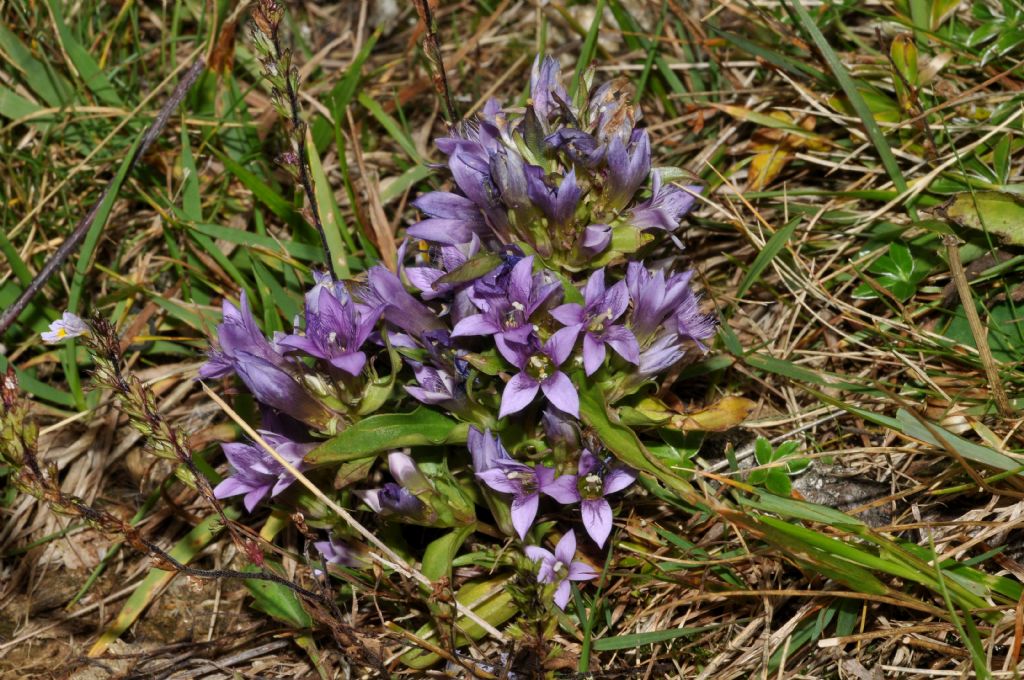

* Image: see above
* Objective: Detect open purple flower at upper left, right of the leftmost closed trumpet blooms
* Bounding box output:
[279,287,383,376]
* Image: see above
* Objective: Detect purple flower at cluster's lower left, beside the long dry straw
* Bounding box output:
[213,430,316,512]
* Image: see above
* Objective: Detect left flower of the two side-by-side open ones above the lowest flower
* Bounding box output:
[476,458,575,539]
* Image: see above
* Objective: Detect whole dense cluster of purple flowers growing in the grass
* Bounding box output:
[184,58,716,607]
